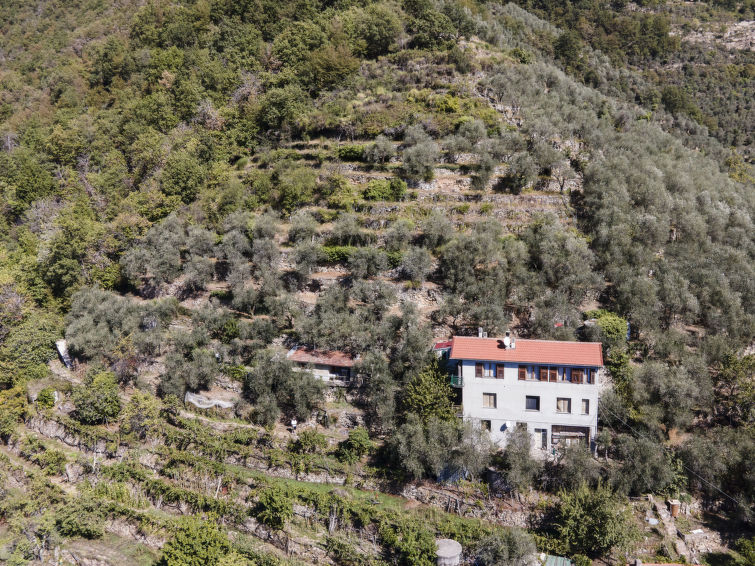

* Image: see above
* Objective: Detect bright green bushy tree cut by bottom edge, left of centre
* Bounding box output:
[158,517,231,566]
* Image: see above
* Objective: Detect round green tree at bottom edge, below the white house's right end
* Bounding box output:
[553,484,634,557]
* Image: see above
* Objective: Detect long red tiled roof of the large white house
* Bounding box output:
[449,336,603,367]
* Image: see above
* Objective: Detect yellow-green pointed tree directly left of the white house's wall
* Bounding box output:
[403,357,456,424]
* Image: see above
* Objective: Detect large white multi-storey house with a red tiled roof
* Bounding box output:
[434,333,603,451]
